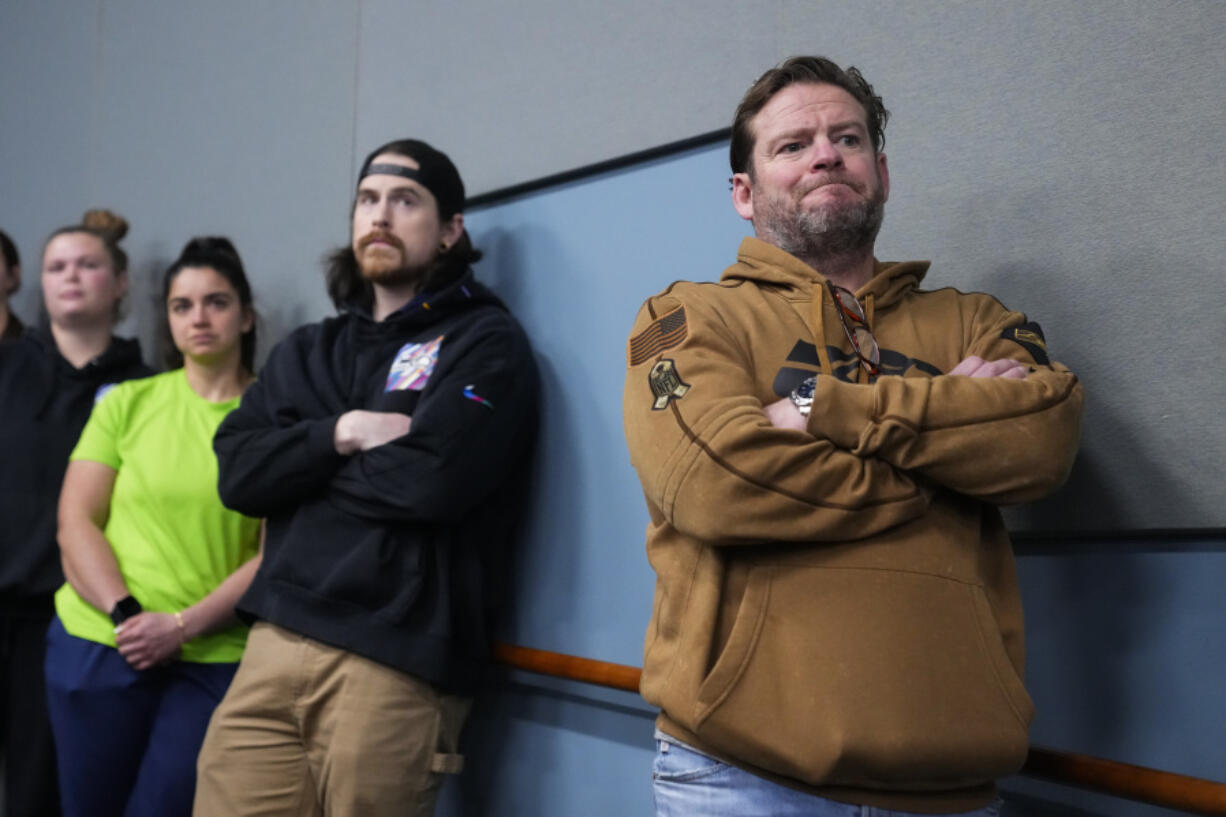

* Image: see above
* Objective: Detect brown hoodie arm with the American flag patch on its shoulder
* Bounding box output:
[624,296,932,545]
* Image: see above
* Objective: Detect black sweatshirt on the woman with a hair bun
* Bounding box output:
[0,330,153,613]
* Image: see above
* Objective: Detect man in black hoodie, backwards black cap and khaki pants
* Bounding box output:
[195,140,537,816]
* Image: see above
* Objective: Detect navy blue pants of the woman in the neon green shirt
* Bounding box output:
[47,618,238,817]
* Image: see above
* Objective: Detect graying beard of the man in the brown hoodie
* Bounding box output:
[754,179,885,259]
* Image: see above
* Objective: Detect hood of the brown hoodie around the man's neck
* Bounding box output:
[720,237,929,312]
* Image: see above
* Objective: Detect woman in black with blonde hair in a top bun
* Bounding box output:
[0,210,152,817]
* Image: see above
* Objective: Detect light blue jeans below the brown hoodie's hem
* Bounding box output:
[651,730,1002,817]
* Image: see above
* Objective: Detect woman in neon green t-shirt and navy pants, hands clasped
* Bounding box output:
[47,238,260,817]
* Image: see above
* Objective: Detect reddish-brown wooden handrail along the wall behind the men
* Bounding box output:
[494,644,1226,817]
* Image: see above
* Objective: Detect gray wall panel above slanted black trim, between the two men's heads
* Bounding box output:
[358,0,776,194]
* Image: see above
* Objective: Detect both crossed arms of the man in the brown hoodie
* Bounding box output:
[625,289,1081,543]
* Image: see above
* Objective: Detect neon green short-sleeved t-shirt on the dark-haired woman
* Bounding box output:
[55,369,260,664]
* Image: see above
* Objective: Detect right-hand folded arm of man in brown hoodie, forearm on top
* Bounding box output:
[808,304,1083,504]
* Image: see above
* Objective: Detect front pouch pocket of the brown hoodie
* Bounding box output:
[683,566,1034,790]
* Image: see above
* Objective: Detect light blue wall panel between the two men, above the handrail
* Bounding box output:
[468,144,748,665]
